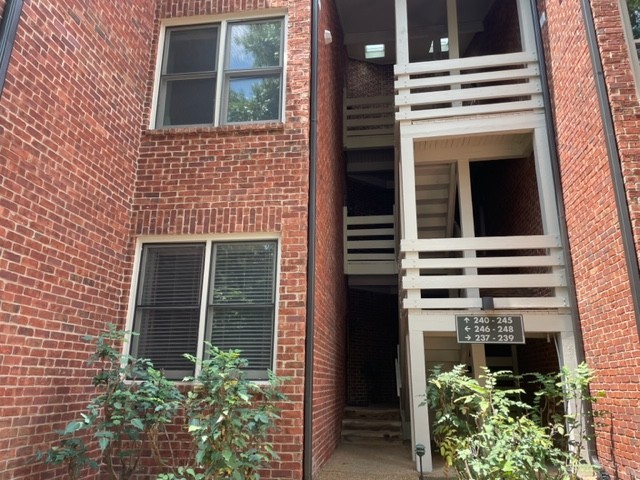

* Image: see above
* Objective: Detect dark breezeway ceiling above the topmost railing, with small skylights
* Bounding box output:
[336,0,505,64]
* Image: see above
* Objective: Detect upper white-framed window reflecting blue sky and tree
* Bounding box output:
[156,18,284,127]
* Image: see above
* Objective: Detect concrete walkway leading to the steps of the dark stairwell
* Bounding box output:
[316,443,455,480]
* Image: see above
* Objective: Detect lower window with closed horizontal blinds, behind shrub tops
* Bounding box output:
[130,239,278,380]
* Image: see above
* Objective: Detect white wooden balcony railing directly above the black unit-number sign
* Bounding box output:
[400,235,568,309]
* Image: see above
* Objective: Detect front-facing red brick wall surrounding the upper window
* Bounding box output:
[133,0,310,479]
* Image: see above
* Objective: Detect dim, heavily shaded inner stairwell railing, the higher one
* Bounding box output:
[343,92,395,149]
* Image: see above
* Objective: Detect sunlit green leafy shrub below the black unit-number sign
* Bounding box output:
[425,364,593,480]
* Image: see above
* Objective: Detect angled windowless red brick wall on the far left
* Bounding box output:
[0,0,153,480]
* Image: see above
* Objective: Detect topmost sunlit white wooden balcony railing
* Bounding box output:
[395,52,543,121]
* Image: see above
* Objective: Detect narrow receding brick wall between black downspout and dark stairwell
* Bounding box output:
[312,0,346,472]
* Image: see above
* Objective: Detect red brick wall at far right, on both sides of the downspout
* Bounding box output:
[539,0,640,480]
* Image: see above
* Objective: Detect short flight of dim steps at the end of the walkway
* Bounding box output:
[342,407,402,444]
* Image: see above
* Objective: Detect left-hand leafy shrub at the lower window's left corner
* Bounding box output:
[38,325,183,480]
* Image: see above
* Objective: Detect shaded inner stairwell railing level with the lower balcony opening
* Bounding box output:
[343,208,398,275]
